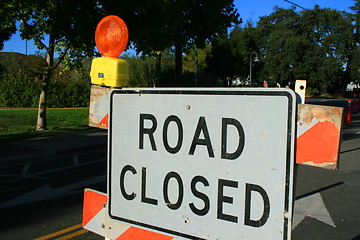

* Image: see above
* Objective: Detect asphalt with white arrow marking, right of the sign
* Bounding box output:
[292,136,360,240]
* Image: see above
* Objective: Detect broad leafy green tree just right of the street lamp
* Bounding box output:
[257,6,353,92]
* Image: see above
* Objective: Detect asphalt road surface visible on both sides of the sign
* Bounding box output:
[0,99,360,240]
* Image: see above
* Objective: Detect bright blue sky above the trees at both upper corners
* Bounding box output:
[2,0,354,54]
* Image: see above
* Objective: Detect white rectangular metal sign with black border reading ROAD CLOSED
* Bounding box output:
[108,88,295,240]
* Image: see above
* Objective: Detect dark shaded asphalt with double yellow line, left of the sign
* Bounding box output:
[0,130,107,240]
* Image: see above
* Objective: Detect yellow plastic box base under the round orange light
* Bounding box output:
[90,57,129,87]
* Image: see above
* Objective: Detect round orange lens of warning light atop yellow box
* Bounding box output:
[95,15,129,57]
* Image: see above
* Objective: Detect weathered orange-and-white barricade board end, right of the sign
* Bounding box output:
[296,104,343,169]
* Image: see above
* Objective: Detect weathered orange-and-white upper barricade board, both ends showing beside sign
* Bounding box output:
[89,85,343,169]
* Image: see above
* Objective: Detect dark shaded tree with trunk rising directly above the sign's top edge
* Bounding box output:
[100,0,239,86]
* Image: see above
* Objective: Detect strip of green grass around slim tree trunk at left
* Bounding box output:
[0,108,89,142]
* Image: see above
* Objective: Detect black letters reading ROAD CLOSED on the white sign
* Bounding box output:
[120,114,270,227]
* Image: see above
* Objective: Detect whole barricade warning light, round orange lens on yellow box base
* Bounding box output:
[90,15,129,87]
